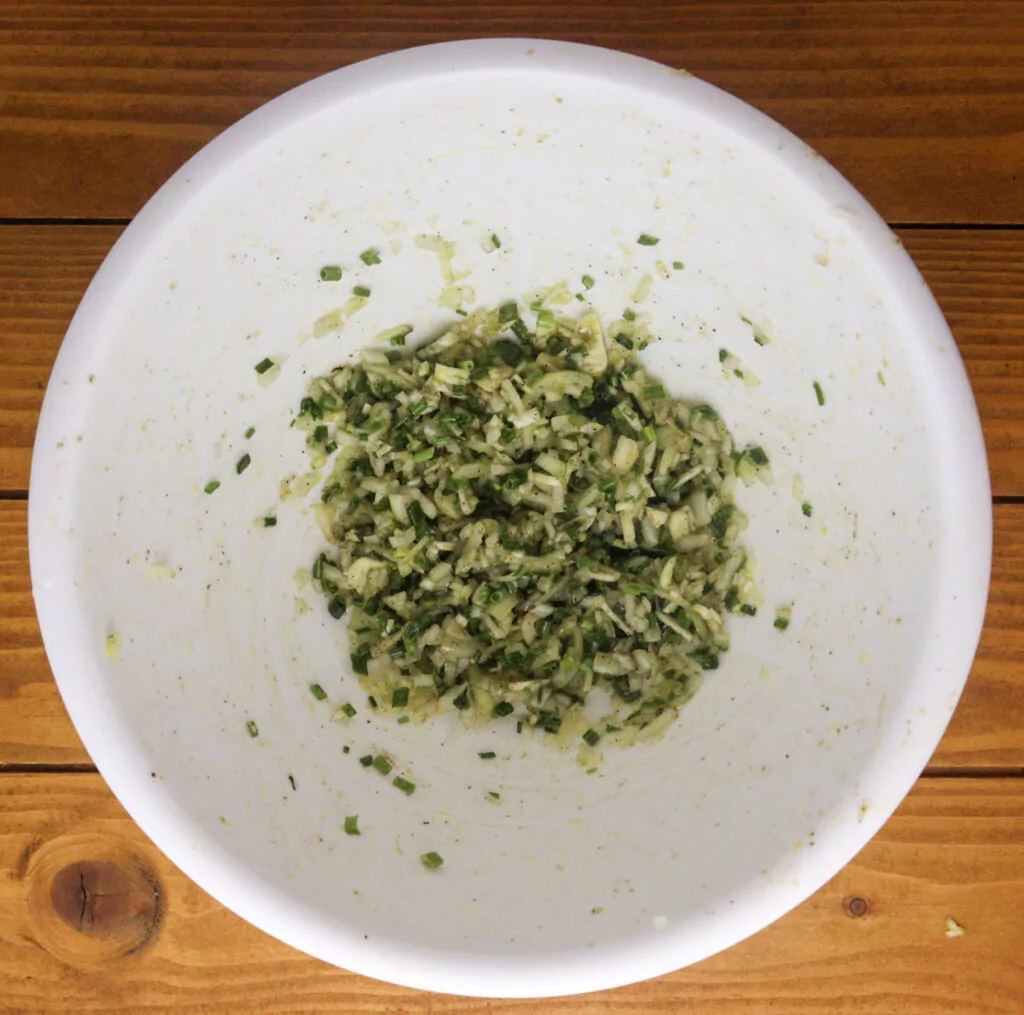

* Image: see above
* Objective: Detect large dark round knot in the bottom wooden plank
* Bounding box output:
[28,836,164,968]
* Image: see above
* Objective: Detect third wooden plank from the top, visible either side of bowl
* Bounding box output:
[0,501,1024,770]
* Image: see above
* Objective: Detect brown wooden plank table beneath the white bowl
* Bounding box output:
[0,0,1024,1015]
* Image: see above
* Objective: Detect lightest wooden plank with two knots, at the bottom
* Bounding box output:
[0,774,1024,1015]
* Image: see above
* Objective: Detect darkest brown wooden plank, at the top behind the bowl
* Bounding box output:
[0,0,1024,222]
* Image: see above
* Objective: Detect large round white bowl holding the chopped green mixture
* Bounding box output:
[30,41,991,997]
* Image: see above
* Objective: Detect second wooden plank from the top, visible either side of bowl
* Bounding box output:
[0,230,1024,496]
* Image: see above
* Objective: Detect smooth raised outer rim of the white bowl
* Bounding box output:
[29,39,991,998]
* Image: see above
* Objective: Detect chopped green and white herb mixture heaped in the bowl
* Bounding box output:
[295,302,770,750]
